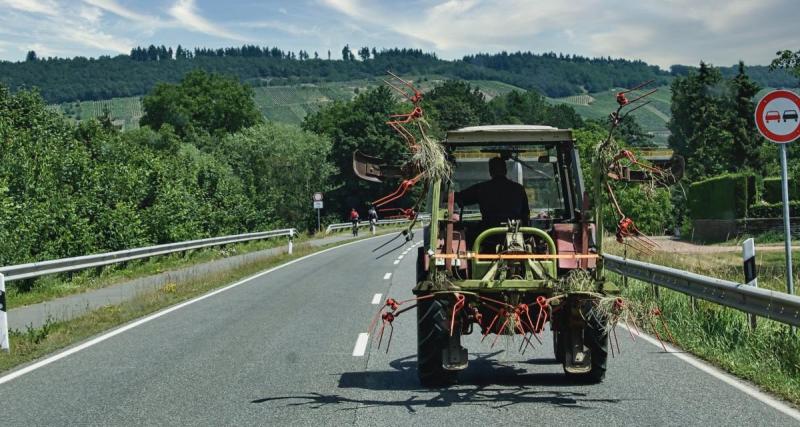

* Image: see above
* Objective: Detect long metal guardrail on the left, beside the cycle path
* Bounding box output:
[0,228,297,281]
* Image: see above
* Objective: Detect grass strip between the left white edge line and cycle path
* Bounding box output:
[0,240,366,372]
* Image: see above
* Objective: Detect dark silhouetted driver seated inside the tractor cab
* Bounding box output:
[455,157,531,228]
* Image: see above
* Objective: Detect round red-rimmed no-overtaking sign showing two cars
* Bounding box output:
[756,89,800,144]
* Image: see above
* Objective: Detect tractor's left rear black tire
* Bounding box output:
[417,298,458,387]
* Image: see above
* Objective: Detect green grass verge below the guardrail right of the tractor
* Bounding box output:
[608,273,800,405]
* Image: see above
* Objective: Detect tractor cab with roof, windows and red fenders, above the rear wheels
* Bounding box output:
[423,125,594,289]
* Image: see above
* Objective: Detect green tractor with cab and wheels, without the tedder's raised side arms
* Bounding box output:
[414,125,618,386]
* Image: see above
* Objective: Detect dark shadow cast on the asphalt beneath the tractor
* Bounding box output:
[251,353,621,412]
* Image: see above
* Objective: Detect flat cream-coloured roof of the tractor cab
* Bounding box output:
[444,125,573,147]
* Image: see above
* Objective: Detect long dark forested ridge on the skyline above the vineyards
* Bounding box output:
[0,46,671,103]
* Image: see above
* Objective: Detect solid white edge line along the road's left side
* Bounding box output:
[0,235,386,384]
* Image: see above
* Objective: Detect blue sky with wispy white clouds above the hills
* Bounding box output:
[0,0,800,68]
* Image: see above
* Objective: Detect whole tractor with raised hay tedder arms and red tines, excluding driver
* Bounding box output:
[354,76,682,386]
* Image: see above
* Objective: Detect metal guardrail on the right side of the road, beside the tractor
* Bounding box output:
[603,255,800,326]
